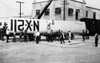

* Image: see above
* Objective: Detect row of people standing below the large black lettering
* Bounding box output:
[6,29,40,44]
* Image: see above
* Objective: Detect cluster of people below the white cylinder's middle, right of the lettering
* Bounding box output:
[47,29,71,44]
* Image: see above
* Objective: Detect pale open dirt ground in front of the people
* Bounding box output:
[0,36,100,63]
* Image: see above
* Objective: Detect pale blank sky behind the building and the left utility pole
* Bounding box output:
[0,0,100,18]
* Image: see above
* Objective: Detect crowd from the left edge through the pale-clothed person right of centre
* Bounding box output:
[0,24,71,44]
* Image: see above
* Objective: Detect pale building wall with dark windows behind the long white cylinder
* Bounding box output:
[32,0,100,21]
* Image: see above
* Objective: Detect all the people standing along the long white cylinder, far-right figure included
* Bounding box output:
[0,24,99,47]
